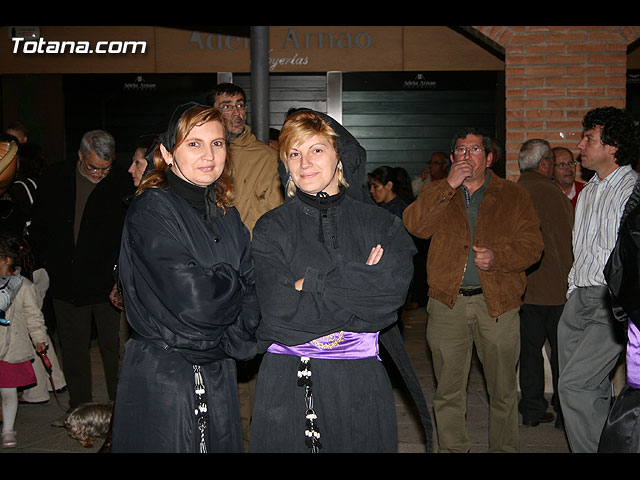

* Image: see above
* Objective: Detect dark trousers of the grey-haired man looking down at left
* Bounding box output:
[53,299,120,408]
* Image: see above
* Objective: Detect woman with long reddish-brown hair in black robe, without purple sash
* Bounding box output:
[112,104,259,452]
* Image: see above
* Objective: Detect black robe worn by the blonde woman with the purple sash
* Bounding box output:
[249,189,415,452]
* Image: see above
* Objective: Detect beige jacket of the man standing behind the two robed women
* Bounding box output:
[231,125,284,232]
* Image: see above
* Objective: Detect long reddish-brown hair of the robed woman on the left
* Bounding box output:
[136,105,233,212]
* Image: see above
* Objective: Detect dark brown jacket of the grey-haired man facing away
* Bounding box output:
[518,171,574,305]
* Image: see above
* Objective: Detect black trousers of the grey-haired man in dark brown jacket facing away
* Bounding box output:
[518,304,564,420]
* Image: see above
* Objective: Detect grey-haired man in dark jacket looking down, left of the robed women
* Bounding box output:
[31,130,131,408]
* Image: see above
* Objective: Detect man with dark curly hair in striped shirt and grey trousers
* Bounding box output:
[558,107,640,453]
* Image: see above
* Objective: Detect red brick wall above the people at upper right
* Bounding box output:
[475,26,640,180]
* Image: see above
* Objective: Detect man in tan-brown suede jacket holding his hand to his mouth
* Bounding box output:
[403,128,543,453]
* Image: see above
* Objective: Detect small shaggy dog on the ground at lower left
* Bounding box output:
[64,403,113,448]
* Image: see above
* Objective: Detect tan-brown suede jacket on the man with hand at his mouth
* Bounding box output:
[403,170,544,317]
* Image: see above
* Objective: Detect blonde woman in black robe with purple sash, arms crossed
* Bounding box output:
[249,110,430,452]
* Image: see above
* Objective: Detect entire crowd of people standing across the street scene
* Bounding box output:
[0,94,640,453]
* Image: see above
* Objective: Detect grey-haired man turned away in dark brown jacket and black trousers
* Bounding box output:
[518,139,573,427]
